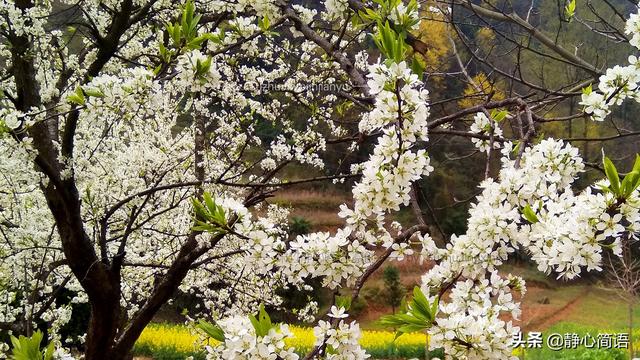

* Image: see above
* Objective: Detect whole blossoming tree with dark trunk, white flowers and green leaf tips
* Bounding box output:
[0,0,640,360]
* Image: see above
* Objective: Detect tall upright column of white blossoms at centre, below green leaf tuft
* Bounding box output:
[348,61,433,231]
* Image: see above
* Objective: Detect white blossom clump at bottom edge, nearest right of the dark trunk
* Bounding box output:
[206,315,299,360]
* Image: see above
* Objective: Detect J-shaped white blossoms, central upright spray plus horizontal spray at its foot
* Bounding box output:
[258,58,433,296]
